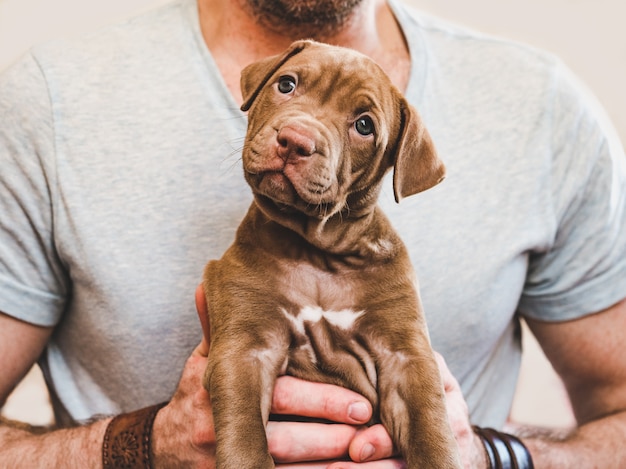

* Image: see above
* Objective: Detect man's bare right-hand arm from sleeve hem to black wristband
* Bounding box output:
[520,299,626,468]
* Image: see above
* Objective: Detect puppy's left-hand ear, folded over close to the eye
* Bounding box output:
[240,41,313,111]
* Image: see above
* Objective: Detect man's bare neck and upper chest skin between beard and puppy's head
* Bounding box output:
[198,0,410,102]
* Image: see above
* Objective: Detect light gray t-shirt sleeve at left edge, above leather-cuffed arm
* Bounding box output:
[0,55,68,326]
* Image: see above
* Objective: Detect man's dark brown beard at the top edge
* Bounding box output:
[241,0,362,39]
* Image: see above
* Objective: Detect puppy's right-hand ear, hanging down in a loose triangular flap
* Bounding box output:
[393,98,446,203]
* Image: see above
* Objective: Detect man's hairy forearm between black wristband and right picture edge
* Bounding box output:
[513,412,626,469]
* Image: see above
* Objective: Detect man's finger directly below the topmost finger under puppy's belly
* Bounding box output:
[267,421,357,462]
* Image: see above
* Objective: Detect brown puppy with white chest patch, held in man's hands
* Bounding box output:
[204,41,460,469]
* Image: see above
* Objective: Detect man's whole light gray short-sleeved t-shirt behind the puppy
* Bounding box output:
[0,0,626,427]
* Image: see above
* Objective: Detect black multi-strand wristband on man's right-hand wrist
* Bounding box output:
[473,427,534,469]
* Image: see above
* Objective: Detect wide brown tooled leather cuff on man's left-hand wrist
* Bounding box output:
[102,402,167,469]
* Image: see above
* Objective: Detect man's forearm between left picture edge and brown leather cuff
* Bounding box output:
[0,419,109,469]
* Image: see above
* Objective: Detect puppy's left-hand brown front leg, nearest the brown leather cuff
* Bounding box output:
[204,336,286,469]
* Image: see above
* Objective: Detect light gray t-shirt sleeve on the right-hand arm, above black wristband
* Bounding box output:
[520,59,626,321]
